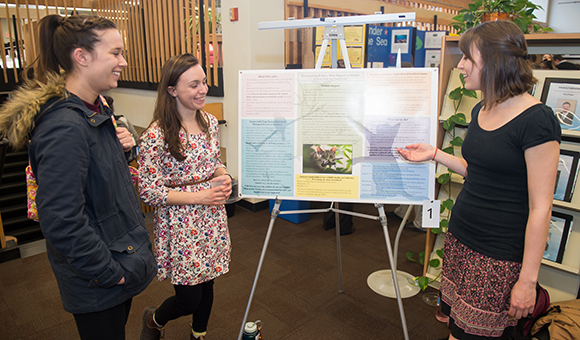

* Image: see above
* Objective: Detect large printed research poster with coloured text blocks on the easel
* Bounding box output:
[238,68,438,204]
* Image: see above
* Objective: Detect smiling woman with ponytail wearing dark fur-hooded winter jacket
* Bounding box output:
[0,15,157,340]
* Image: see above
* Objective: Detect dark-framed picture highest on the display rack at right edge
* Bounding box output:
[540,78,580,131]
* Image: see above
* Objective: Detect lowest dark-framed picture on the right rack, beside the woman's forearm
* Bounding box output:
[543,211,574,263]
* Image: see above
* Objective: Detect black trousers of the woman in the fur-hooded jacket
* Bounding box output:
[73,299,133,340]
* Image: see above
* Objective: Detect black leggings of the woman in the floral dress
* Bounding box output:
[155,280,213,333]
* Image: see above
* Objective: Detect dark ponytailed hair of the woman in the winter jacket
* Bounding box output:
[34,14,117,83]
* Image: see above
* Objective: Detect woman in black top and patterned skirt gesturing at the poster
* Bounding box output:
[398,21,561,340]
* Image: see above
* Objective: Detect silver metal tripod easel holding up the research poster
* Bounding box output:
[238,13,415,340]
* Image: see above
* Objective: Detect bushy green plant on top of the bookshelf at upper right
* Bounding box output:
[451,0,552,34]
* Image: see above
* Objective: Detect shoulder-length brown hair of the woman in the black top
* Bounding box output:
[459,21,536,108]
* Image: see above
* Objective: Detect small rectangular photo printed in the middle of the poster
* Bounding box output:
[302,144,352,174]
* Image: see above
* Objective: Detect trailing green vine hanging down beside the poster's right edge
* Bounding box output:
[406,73,477,290]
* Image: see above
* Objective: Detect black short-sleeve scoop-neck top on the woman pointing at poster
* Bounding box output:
[449,103,561,262]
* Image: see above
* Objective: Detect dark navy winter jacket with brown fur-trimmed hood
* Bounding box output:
[0,73,157,314]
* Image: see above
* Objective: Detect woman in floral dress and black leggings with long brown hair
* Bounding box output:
[139,54,231,339]
